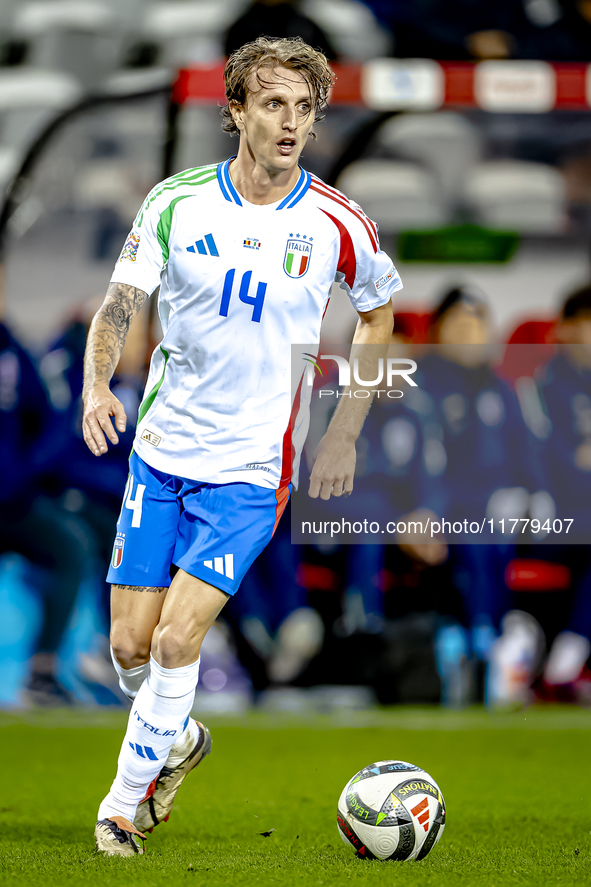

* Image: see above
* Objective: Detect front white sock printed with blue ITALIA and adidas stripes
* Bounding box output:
[98,656,199,822]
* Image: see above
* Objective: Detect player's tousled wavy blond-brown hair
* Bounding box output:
[221,37,334,135]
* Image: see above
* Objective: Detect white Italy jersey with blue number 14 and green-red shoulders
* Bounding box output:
[112,160,402,489]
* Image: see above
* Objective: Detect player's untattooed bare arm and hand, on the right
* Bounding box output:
[308,301,394,499]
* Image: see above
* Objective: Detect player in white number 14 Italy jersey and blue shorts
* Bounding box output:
[83,38,402,856]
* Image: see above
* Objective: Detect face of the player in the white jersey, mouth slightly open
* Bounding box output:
[233,68,314,173]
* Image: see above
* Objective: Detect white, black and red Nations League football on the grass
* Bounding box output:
[337,761,445,860]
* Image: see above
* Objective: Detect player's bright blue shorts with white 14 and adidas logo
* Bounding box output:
[107,453,291,595]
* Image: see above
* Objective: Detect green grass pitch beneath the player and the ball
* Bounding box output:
[0,709,591,887]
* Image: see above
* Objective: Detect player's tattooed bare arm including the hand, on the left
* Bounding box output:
[82,283,148,456]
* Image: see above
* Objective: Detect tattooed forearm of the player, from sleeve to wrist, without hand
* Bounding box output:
[84,283,148,391]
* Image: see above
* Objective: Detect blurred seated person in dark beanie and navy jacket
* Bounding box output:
[420,286,539,703]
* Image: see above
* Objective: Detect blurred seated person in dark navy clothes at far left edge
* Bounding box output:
[0,288,94,706]
